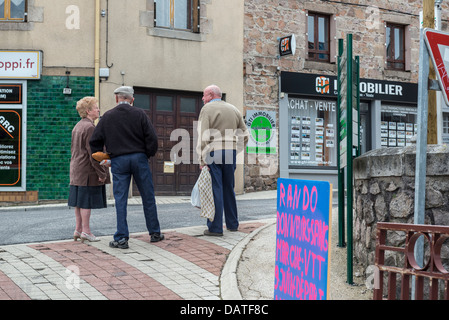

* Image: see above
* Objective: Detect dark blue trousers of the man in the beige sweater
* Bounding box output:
[206,150,239,233]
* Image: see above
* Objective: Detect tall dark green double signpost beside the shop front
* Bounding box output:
[337,34,361,284]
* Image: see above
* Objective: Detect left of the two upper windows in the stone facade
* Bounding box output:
[307,12,331,62]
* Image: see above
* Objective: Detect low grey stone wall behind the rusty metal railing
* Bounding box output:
[353,145,449,270]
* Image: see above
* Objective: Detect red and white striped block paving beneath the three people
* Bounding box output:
[0,220,266,300]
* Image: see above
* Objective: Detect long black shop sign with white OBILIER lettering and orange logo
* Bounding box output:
[281,71,418,104]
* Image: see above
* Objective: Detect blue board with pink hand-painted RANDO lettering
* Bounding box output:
[274,178,332,300]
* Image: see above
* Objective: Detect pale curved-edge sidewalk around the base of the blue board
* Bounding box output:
[233,206,373,300]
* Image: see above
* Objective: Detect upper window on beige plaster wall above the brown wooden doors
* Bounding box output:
[154,0,199,32]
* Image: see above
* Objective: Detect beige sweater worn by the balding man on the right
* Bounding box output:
[196,101,249,165]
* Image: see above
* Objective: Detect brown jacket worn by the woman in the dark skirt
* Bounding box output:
[70,118,111,186]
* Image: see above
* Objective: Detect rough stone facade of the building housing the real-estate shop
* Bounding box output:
[243,0,449,190]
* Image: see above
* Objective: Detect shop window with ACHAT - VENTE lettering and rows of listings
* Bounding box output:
[288,98,337,169]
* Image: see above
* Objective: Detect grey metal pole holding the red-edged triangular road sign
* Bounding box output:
[412,29,429,299]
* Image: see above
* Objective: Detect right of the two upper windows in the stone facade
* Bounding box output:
[386,23,406,70]
